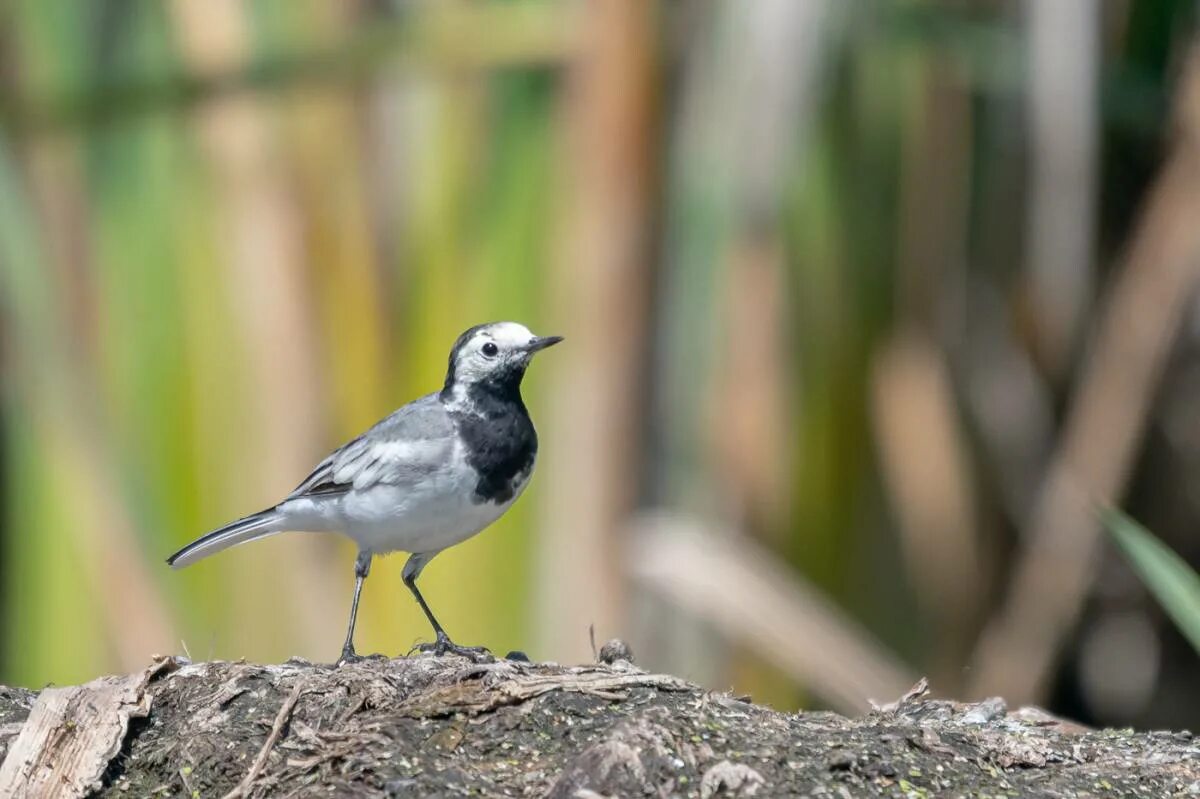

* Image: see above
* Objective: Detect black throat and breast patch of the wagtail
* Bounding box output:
[450,370,538,505]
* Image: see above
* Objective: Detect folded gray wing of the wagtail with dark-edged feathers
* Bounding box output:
[288,394,455,499]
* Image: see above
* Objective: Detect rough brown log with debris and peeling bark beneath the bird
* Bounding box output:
[0,655,1200,799]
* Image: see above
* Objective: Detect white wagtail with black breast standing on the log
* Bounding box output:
[167,322,563,661]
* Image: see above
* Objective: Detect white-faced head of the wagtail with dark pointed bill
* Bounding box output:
[442,322,563,402]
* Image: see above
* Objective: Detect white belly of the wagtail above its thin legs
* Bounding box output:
[280,441,532,554]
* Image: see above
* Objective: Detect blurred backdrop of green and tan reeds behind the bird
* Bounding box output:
[0,0,1200,727]
